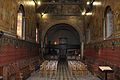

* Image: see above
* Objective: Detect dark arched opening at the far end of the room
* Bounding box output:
[44,23,80,59]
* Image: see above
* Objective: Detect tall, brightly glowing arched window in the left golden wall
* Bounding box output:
[17,4,25,39]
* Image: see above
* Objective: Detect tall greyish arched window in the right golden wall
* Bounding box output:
[104,6,113,39]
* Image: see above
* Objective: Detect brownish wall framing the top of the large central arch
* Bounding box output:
[39,14,83,41]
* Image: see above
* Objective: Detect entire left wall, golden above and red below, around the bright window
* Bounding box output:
[0,0,42,80]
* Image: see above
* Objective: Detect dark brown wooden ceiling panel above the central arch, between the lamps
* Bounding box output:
[36,0,84,15]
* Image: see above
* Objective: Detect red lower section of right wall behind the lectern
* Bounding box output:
[84,38,120,80]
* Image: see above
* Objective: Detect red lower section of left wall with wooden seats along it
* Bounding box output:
[0,36,43,80]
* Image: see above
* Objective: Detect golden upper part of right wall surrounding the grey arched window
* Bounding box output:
[86,0,120,42]
